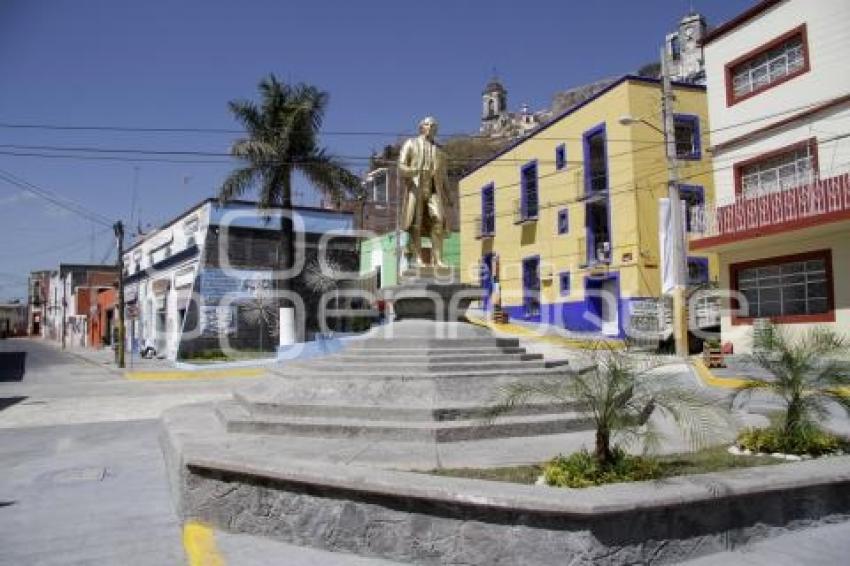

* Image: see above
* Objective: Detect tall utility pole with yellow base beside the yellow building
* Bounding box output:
[661,47,688,357]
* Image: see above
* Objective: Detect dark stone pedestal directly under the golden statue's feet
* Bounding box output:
[381,266,484,322]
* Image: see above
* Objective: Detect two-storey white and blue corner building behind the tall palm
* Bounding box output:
[124,199,358,359]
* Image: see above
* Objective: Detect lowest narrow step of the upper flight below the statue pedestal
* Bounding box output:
[268,361,574,381]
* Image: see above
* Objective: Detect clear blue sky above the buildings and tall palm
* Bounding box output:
[0,0,753,300]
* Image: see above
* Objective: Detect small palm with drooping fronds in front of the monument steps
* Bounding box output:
[488,344,729,468]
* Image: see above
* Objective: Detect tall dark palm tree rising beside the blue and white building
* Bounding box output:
[218,74,360,302]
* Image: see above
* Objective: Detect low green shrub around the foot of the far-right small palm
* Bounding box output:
[736,425,843,456]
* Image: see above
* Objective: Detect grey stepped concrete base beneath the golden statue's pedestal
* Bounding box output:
[216,322,590,443]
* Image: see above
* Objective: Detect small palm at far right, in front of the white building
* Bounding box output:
[731,327,850,440]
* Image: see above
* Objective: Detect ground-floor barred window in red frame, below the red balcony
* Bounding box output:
[737,257,831,317]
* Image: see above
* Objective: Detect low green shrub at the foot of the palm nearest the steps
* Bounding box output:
[543,448,663,487]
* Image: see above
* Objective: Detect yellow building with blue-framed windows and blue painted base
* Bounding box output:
[460,76,716,337]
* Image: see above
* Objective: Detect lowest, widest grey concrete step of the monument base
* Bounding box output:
[216,403,592,443]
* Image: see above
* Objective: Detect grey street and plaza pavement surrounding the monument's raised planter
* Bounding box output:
[0,339,850,566]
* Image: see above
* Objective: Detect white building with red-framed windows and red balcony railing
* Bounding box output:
[691,0,850,351]
